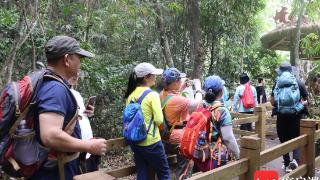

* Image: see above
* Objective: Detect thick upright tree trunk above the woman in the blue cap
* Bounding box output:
[187,0,204,79]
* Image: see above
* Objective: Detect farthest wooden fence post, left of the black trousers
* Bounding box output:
[254,106,267,150]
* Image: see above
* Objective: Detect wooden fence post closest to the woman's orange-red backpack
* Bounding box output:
[240,136,261,180]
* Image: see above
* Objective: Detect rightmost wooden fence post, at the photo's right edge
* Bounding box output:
[299,119,316,177]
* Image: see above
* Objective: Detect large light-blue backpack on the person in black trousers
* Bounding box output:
[273,72,303,114]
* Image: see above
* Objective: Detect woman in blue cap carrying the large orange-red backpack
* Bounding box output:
[197,76,240,171]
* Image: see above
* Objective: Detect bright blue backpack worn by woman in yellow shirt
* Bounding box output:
[122,89,156,144]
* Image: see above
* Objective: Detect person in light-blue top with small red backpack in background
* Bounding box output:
[233,73,258,131]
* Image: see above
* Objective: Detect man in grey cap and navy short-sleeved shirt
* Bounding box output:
[30,36,106,180]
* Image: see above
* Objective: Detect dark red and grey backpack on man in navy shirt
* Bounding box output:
[0,70,77,177]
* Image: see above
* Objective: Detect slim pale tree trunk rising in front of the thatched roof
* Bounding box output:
[291,0,305,77]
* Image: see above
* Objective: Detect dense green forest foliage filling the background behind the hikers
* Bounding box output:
[0,0,282,138]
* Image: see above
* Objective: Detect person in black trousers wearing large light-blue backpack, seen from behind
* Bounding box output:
[270,62,308,173]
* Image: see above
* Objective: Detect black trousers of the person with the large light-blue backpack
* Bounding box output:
[277,113,302,166]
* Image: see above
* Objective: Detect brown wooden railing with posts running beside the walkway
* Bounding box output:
[75,104,320,180]
